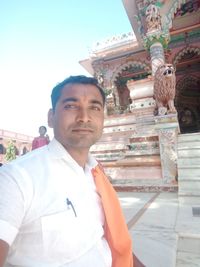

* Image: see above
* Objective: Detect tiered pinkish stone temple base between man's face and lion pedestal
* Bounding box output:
[91,111,162,185]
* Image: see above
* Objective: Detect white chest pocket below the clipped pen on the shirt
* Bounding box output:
[41,208,82,264]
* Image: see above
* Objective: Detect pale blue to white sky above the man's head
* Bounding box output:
[0,0,132,136]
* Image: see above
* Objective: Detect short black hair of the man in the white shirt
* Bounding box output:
[51,75,106,110]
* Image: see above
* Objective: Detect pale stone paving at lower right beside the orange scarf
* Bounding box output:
[118,192,200,267]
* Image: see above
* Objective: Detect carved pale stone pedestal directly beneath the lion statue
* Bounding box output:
[154,114,179,184]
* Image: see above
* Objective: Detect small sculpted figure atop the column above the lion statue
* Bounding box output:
[145,4,161,32]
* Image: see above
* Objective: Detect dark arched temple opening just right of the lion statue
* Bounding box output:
[174,46,200,133]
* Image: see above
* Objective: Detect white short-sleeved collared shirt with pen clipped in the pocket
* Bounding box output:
[0,139,111,267]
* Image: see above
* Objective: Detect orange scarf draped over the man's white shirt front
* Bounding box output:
[92,165,134,267]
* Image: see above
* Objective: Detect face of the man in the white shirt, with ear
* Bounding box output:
[49,84,104,152]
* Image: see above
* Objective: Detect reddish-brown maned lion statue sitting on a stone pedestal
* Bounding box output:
[153,64,176,115]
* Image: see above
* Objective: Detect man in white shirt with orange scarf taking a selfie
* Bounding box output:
[0,76,133,267]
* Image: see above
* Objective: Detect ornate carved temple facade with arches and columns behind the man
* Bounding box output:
[80,0,200,193]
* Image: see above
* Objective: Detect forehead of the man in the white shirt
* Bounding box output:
[60,84,103,103]
